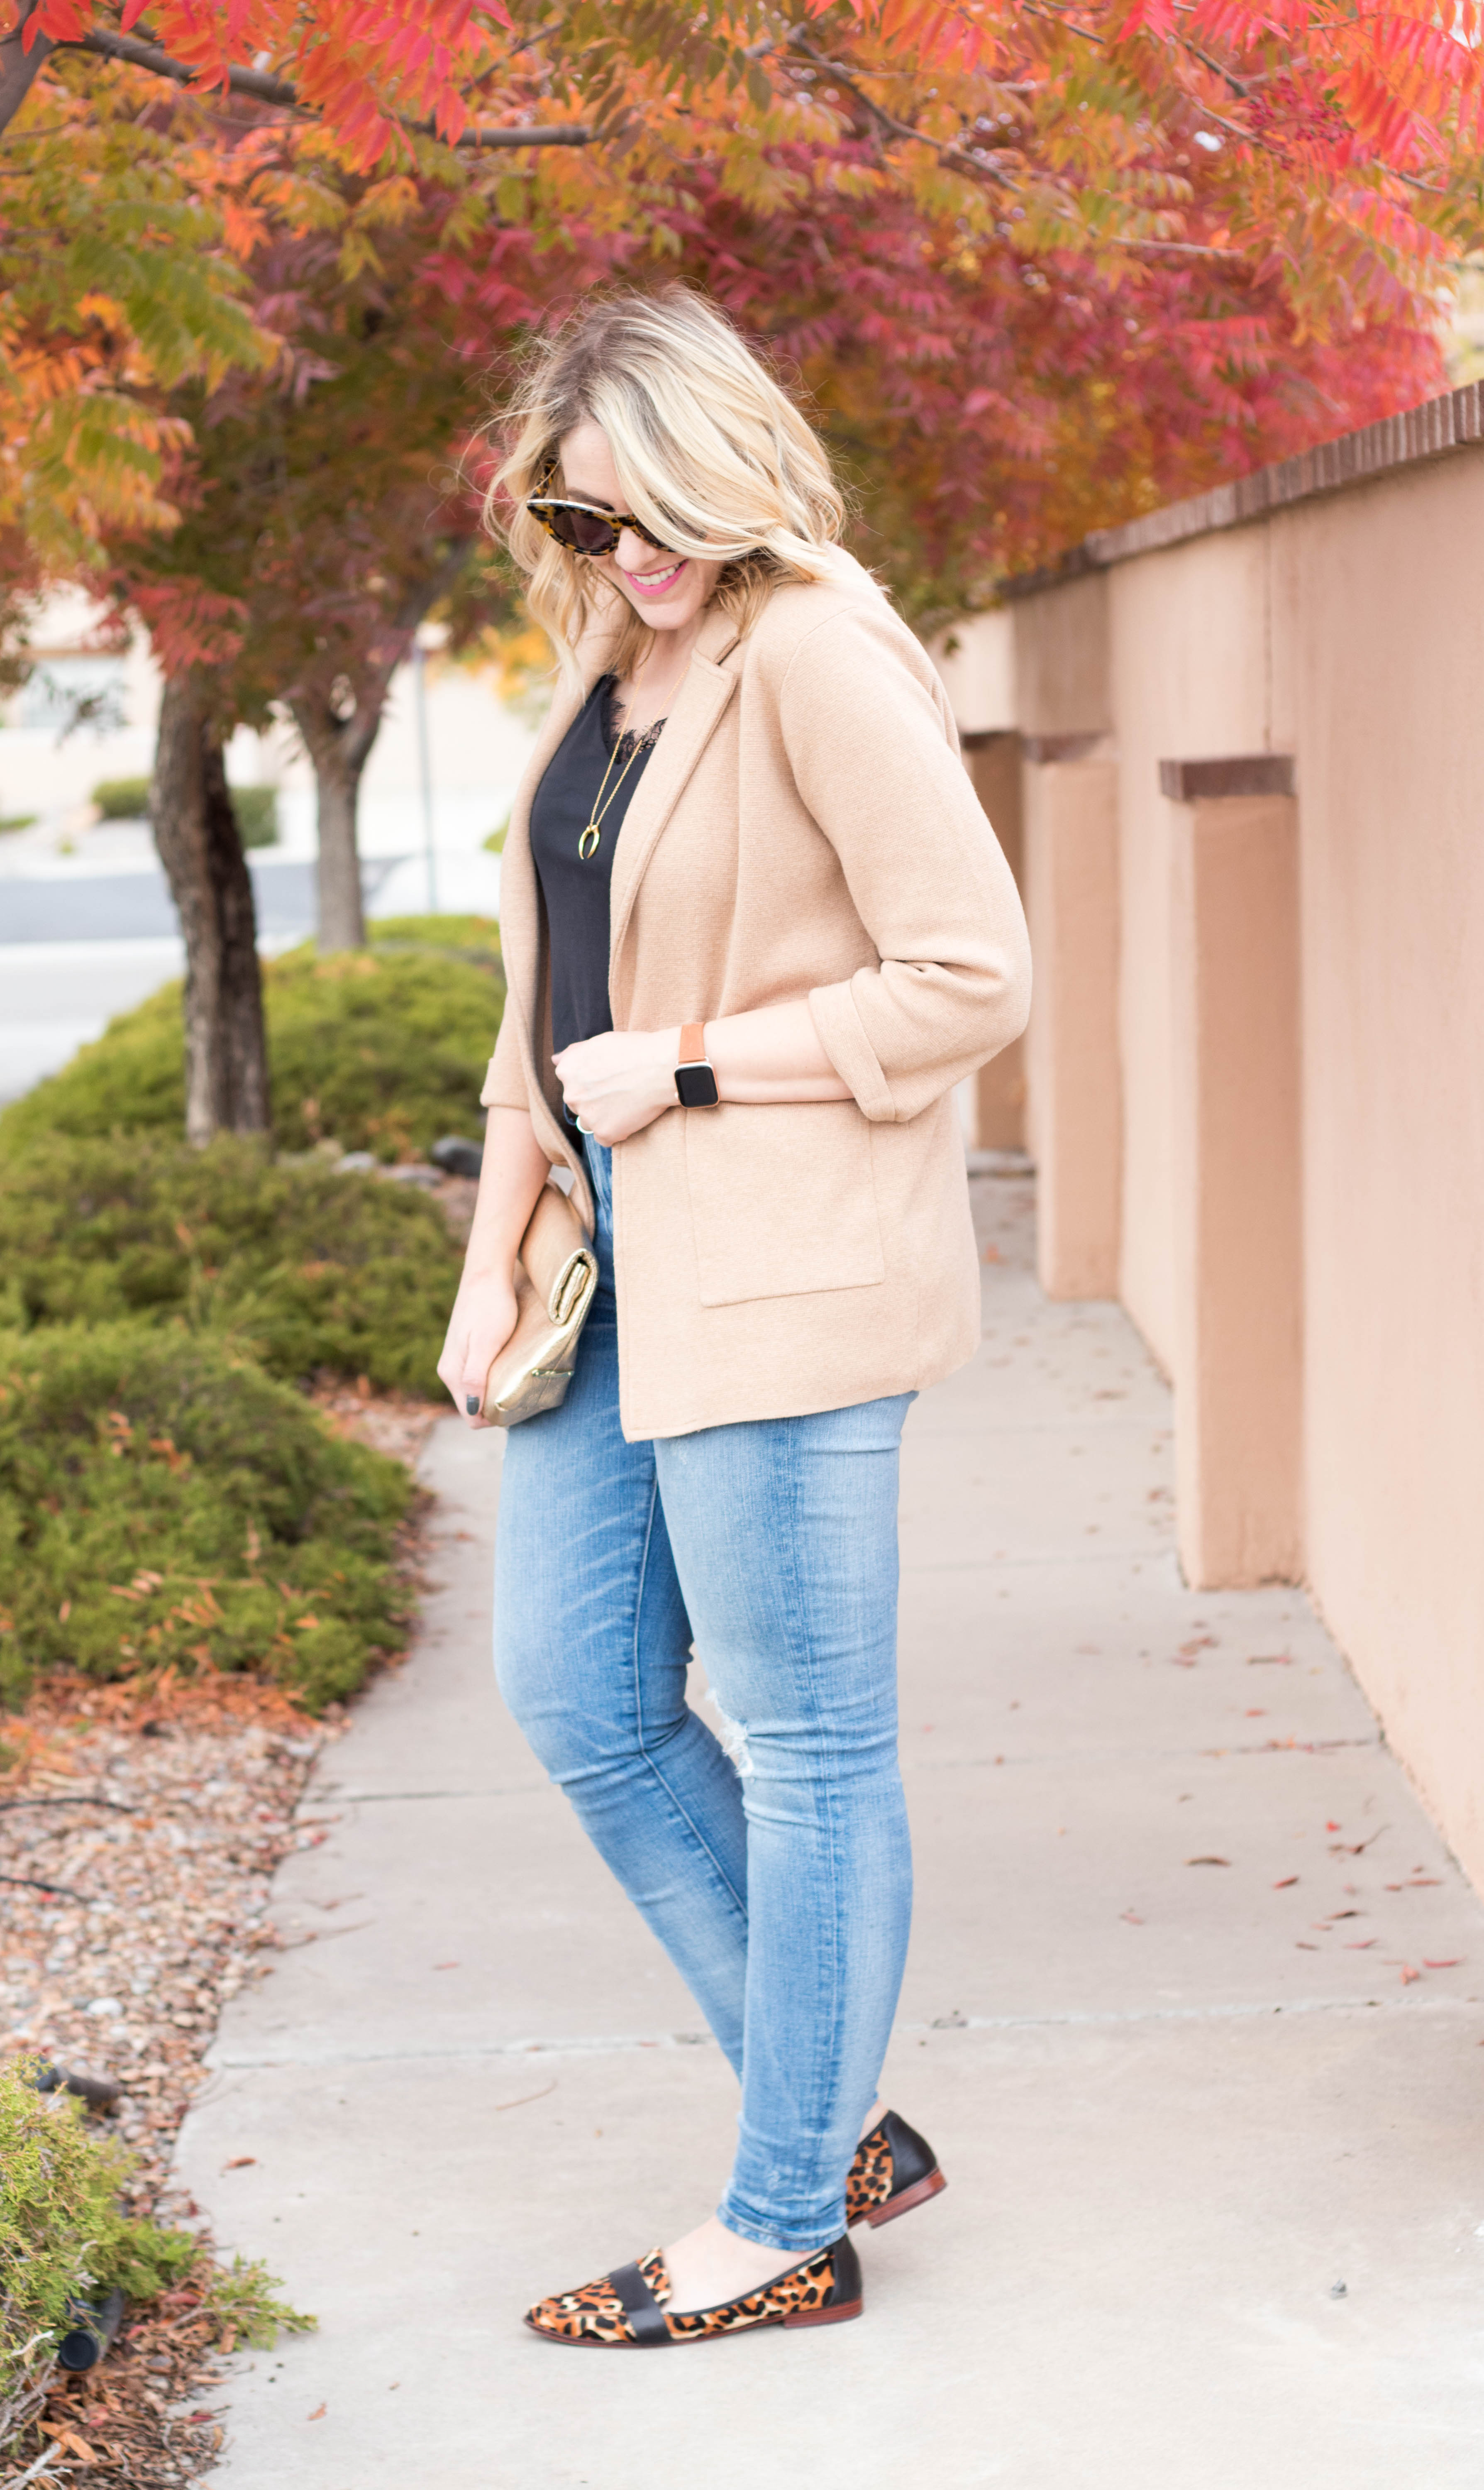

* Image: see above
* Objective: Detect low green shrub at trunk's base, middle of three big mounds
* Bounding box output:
[0,1136,458,1392]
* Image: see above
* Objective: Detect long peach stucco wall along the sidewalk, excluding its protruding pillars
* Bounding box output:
[1016,433,1484,1882]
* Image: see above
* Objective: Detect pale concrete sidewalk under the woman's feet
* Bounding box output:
[179,1178,1484,2490]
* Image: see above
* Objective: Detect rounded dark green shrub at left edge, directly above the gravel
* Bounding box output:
[0,1322,411,1711]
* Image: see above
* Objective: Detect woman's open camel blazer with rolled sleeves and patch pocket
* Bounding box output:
[483,555,1031,1442]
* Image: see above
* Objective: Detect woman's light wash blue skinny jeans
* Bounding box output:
[495,1141,914,2256]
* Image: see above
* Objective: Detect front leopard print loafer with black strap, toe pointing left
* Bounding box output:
[525,2238,862,2351]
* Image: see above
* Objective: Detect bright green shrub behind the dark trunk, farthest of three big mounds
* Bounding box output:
[0,916,505,1161]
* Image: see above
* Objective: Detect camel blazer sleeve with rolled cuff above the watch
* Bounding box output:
[779,605,1031,1123]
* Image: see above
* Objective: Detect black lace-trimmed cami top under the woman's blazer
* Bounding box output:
[530,675,665,1056]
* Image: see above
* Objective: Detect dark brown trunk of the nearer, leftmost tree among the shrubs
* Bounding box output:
[149,670,269,1148]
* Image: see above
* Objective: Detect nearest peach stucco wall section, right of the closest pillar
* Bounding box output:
[1272,453,1484,1882]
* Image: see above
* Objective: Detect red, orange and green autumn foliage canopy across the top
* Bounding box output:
[0,0,1484,1145]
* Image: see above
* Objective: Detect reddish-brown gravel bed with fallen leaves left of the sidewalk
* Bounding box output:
[0,1387,438,2490]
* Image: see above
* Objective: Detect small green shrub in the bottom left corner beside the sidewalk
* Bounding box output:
[0,2059,314,2453]
